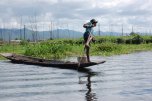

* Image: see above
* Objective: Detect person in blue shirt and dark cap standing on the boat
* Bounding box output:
[83,19,98,62]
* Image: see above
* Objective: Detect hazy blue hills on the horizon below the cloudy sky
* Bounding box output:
[0,28,121,41]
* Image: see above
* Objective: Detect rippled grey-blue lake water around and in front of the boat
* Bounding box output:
[0,52,152,101]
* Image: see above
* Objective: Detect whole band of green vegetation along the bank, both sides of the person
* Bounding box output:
[0,33,152,59]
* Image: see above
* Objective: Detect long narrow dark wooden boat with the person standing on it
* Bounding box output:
[0,53,105,69]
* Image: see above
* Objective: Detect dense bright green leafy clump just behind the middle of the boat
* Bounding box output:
[25,42,72,59]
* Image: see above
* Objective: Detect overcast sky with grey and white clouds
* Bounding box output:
[0,0,152,29]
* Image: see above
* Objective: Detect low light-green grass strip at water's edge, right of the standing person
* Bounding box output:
[92,43,152,56]
